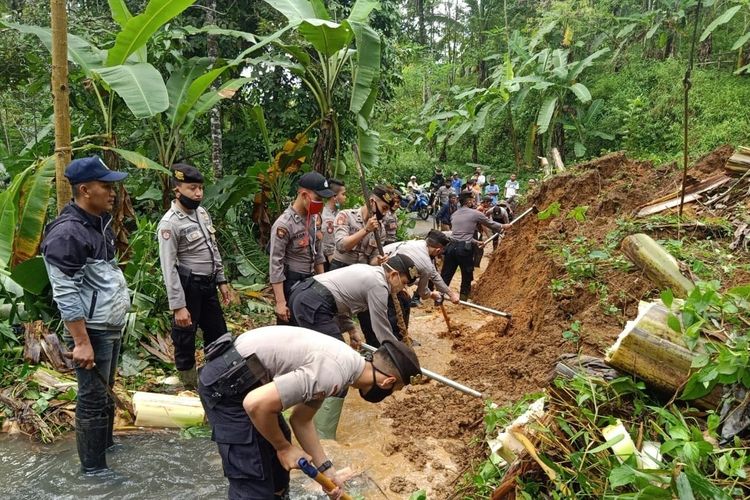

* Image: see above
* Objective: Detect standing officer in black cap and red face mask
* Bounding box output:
[268,172,335,325]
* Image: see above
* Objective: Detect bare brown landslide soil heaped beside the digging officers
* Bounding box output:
[384,147,732,498]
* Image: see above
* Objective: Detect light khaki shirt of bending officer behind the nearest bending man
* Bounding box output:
[313,264,396,342]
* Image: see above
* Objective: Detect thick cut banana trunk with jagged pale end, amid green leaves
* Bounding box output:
[605,302,721,410]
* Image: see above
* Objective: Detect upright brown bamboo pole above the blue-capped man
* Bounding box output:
[50,0,72,214]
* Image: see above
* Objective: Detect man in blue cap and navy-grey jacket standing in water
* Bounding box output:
[41,156,130,473]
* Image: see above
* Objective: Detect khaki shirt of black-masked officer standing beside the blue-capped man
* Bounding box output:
[156,201,226,310]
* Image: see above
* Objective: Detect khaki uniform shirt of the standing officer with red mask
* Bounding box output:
[268,206,325,283]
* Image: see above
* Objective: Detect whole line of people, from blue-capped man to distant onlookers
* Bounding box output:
[41,156,519,499]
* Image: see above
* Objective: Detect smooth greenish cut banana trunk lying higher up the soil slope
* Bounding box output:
[620,233,695,298]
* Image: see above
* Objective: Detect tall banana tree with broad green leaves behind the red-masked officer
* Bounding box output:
[265,0,380,175]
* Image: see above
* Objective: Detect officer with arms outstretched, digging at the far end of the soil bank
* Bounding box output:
[441,191,509,300]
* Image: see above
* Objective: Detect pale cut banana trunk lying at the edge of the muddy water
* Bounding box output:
[133,392,206,427]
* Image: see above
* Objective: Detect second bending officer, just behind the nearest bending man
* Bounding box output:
[291,255,418,439]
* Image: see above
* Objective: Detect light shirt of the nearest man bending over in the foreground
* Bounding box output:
[234,325,365,409]
